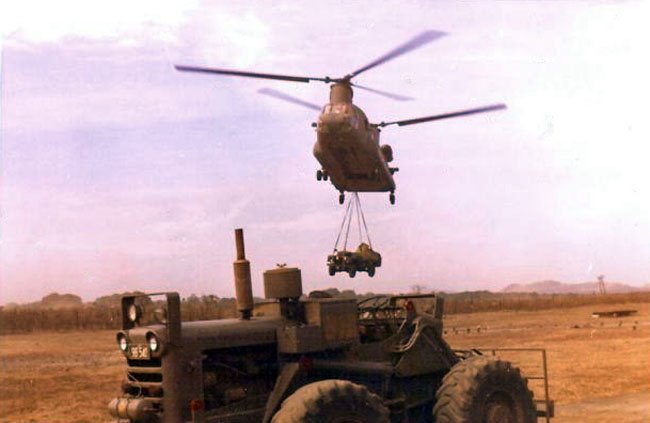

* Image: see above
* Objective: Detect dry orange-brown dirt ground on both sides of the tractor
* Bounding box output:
[0,304,650,423]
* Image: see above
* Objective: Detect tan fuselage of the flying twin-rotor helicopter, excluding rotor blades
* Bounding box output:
[314,84,395,192]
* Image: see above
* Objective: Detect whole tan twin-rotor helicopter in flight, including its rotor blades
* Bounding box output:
[174,31,506,204]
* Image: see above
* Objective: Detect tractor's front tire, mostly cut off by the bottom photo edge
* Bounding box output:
[271,379,390,423]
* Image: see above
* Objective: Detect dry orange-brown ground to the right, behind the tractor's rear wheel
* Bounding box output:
[445,303,650,423]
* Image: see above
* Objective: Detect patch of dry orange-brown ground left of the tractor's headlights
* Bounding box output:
[0,331,124,423]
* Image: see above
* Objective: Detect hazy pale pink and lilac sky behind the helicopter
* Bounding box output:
[0,0,650,304]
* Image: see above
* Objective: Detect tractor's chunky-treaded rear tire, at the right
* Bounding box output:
[433,356,537,423]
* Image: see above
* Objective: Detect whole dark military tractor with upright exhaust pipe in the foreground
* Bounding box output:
[109,229,552,423]
